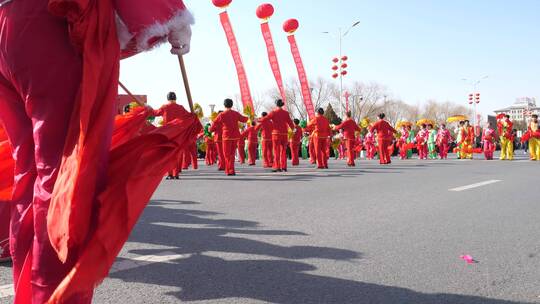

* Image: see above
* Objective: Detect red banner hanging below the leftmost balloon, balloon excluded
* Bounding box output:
[219,11,253,111]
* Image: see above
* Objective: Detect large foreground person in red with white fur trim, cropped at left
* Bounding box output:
[0,0,193,304]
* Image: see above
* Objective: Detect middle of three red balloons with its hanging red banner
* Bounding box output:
[256,3,287,104]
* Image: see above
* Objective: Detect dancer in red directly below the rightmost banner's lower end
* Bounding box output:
[307,108,332,169]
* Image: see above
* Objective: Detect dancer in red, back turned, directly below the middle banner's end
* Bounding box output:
[260,99,295,172]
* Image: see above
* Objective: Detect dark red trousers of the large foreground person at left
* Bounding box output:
[0,0,94,304]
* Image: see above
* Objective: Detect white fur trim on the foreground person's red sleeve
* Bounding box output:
[137,9,195,52]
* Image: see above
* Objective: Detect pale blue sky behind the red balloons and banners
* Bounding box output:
[121,0,540,114]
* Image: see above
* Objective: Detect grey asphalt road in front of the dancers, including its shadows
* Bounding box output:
[0,153,540,304]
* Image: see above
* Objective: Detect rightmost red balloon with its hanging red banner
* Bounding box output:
[283,19,315,119]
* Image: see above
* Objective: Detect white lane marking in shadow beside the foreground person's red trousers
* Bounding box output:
[0,251,191,299]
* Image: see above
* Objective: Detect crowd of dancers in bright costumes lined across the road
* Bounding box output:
[149,93,540,179]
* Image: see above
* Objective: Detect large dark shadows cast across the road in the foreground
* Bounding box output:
[111,200,532,304]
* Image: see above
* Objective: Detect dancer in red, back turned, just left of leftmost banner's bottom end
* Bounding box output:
[215,98,249,176]
